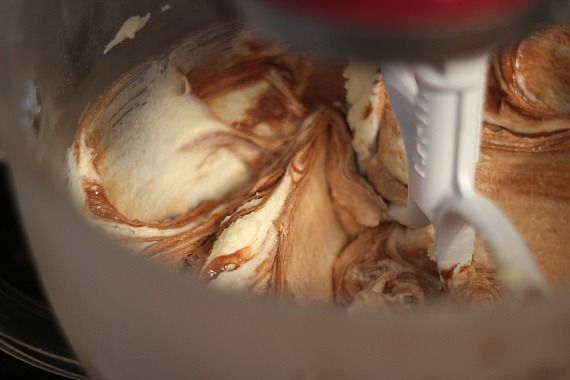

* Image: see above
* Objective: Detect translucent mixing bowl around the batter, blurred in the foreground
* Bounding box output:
[0,0,570,379]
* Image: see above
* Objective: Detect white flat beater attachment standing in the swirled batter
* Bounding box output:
[382,55,544,296]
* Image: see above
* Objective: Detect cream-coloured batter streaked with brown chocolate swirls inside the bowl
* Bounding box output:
[69,27,570,312]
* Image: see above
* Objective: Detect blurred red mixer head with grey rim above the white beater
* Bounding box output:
[239,0,556,60]
